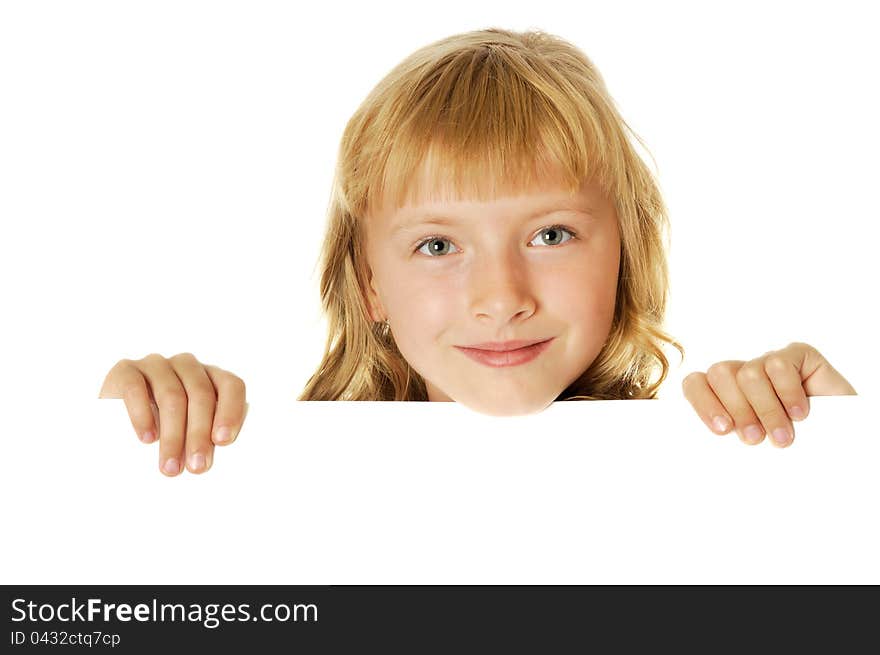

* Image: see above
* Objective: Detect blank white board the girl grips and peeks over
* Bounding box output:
[0,396,880,584]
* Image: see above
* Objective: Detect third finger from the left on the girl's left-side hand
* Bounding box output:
[168,353,217,473]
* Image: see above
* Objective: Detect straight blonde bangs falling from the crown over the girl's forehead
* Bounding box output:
[346,35,619,216]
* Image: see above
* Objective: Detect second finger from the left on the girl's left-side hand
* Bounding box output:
[138,354,187,476]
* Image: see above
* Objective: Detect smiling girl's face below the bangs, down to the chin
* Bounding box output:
[366,178,620,415]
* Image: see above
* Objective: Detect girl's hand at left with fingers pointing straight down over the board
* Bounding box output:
[98,353,247,476]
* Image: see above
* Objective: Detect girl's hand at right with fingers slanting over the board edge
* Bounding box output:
[681,343,856,448]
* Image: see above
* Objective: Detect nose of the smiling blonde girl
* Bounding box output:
[468,252,537,326]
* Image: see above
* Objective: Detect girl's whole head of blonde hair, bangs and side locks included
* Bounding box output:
[300,29,684,400]
